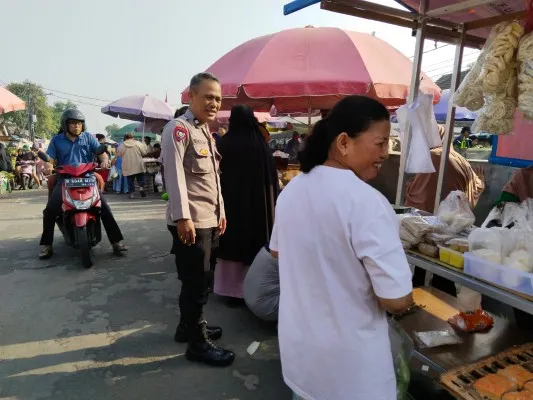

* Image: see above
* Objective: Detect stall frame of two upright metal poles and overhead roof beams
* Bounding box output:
[284,0,526,211]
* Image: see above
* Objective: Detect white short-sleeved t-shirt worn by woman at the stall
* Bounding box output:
[270,166,412,400]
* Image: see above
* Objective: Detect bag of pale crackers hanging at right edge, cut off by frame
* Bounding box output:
[517,32,533,119]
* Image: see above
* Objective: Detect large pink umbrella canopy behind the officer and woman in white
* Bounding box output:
[182,27,441,113]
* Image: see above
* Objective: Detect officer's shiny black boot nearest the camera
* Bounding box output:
[185,321,235,367]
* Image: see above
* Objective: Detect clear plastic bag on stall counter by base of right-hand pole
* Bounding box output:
[437,190,476,233]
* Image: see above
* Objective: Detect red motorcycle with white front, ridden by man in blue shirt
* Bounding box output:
[56,163,102,268]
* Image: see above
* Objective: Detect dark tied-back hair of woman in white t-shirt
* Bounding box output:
[298,96,390,173]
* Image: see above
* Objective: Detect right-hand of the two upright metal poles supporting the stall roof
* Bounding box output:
[434,26,466,213]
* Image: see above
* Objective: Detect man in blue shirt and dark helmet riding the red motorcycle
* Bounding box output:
[39,109,128,260]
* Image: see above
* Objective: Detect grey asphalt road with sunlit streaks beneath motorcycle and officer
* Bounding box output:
[0,190,291,400]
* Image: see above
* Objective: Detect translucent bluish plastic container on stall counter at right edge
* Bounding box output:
[464,253,533,296]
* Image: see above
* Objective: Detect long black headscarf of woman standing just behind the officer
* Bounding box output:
[217,105,279,265]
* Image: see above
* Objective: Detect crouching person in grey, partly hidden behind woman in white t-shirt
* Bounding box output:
[243,246,280,321]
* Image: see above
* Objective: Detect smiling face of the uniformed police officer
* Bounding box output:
[189,80,222,123]
